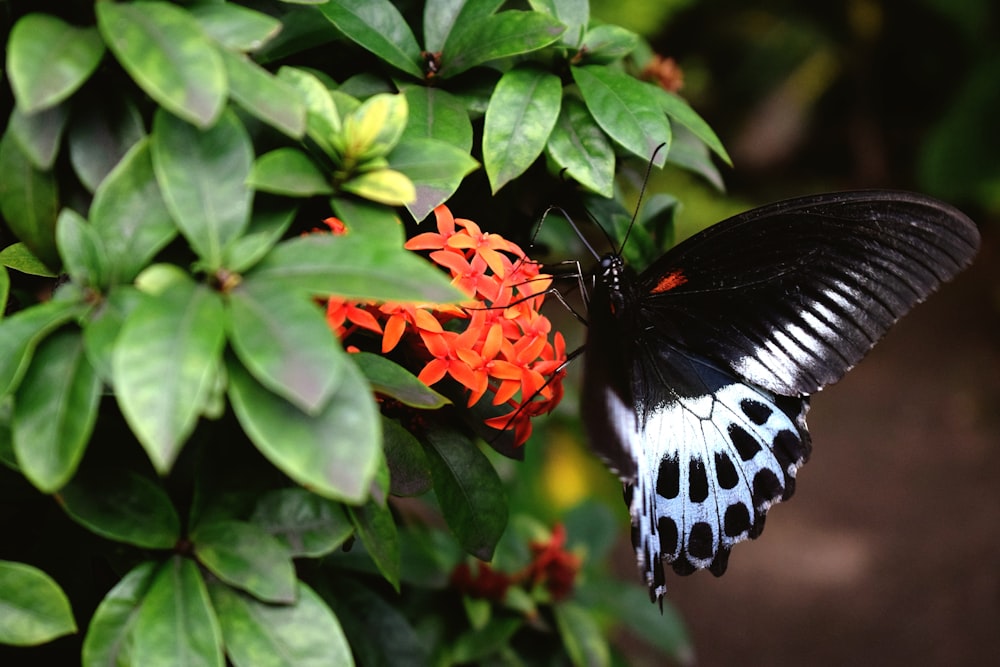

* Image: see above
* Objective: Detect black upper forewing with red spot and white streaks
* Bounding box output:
[637,191,979,396]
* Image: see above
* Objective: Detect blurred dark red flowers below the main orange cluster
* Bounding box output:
[451,524,582,601]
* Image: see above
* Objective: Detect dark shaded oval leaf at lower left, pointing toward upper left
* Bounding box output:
[59,469,181,549]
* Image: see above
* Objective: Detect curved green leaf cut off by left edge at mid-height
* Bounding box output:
[0,300,81,396]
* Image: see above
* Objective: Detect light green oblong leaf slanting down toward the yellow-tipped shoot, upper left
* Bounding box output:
[221,50,306,139]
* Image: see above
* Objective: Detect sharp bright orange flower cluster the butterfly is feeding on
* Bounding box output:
[325,206,566,445]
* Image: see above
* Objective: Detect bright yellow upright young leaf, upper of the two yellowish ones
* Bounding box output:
[344,93,408,163]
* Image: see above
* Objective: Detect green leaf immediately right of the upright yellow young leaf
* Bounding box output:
[402,85,472,154]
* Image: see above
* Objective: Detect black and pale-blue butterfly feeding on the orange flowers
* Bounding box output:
[581,191,979,604]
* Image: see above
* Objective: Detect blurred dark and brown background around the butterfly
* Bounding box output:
[545,0,1000,665]
